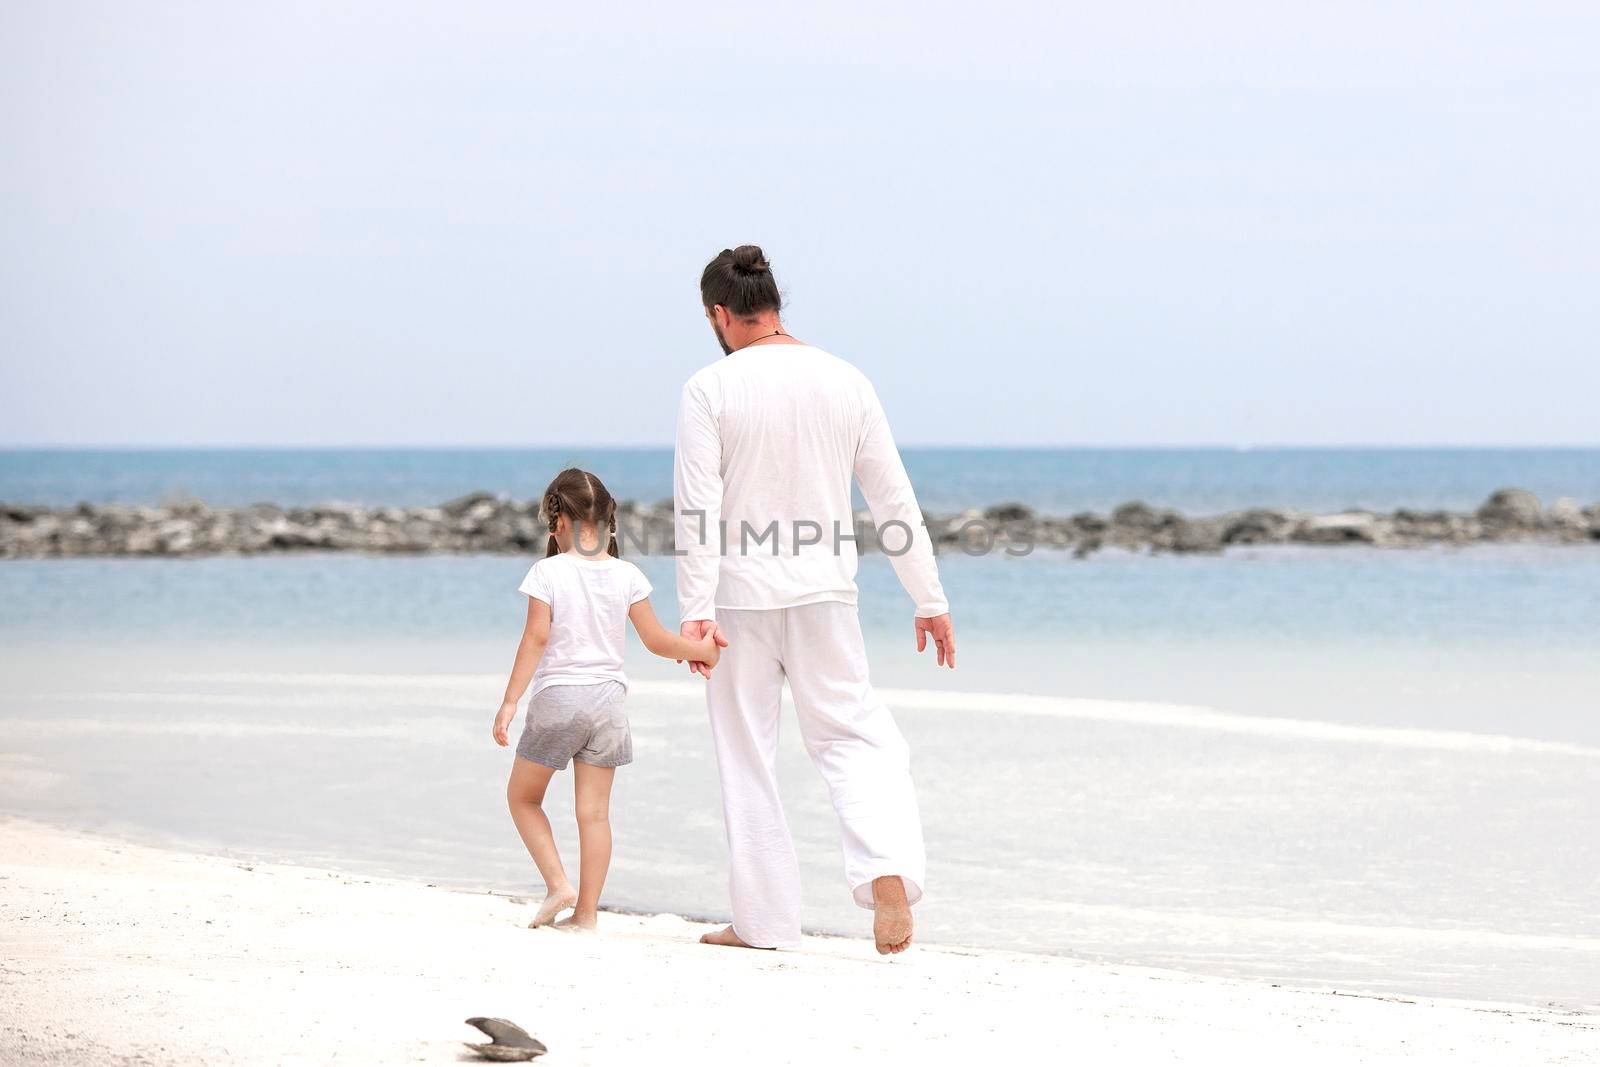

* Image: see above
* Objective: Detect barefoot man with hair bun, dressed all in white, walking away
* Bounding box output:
[674,245,955,953]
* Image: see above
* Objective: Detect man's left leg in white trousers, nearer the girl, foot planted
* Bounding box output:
[706,611,800,949]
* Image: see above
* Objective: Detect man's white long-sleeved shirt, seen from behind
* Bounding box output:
[672,344,950,622]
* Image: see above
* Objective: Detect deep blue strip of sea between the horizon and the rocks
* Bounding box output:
[9,446,1600,514]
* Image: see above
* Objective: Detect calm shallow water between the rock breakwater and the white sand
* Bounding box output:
[0,454,1600,1011]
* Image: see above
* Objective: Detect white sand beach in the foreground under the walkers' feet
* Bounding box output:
[0,817,1600,1064]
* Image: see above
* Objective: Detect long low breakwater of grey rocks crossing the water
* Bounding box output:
[0,490,1600,560]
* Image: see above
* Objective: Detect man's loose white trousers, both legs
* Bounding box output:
[706,601,926,947]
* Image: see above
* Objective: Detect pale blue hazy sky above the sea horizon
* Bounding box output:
[0,0,1600,445]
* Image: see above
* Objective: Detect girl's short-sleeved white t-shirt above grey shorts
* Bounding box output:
[518,552,650,696]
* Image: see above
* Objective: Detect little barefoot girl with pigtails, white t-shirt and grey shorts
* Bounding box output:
[494,467,718,929]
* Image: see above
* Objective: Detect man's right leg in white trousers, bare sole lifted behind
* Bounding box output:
[782,601,928,953]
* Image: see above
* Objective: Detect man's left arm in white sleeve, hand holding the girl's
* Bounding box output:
[672,379,726,677]
